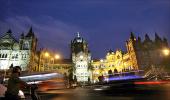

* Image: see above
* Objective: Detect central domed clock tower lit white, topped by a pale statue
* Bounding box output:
[71,32,91,82]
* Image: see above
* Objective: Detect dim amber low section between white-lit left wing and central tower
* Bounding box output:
[37,49,72,75]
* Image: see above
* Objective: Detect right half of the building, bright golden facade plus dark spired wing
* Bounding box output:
[91,33,169,81]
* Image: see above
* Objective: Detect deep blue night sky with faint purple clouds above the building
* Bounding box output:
[0,0,170,58]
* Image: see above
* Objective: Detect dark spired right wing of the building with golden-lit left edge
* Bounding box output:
[126,33,169,70]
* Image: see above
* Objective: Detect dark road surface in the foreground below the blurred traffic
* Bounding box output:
[35,85,170,100]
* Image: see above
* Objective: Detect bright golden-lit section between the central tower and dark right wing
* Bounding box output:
[91,50,134,82]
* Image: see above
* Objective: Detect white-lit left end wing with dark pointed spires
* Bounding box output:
[0,28,37,71]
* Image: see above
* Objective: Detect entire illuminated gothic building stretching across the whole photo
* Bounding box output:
[0,28,169,82]
